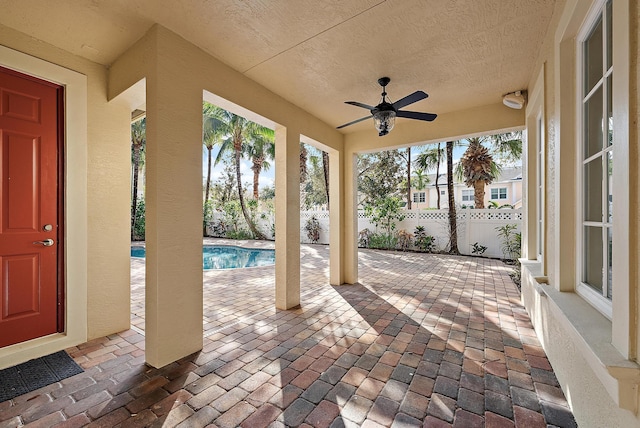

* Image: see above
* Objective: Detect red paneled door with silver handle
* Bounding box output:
[0,68,62,347]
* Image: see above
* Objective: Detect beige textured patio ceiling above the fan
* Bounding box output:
[0,0,555,132]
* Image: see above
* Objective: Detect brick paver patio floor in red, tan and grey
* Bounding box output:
[0,242,576,428]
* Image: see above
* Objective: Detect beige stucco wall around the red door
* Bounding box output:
[0,25,131,364]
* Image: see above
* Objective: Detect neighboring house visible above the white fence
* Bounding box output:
[411,167,522,209]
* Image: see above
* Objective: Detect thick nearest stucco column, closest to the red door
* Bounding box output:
[145,74,203,367]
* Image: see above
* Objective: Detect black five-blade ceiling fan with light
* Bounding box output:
[336,77,437,137]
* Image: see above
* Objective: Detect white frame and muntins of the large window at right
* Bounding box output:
[576,0,617,320]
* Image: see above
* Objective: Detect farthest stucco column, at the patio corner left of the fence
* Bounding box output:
[342,150,358,284]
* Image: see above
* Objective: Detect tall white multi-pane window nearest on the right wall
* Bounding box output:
[577,0,613,310]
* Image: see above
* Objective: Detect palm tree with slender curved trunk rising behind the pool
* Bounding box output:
[215,109,268,239]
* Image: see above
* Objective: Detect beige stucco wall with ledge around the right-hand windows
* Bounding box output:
[522,0,640,427]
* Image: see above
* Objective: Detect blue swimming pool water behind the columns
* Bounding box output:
[131,245,276,269]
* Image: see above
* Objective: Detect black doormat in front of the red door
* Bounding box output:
[0,351,84,403]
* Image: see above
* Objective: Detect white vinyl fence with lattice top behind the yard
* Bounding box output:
[207,208,522,258]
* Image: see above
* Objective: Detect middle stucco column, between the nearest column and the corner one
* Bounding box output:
[275,126,300,309]
